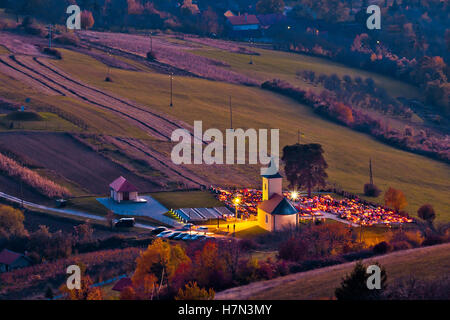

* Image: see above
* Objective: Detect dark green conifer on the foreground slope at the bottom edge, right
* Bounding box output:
[334,261,387,300]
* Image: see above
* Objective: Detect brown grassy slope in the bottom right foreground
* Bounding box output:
[216,244,450,300]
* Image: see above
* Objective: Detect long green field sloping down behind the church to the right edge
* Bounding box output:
[51,50,450,221]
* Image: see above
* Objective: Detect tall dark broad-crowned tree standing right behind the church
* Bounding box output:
[282,143,328,197]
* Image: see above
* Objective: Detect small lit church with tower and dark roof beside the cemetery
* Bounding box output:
[258,172,298,232]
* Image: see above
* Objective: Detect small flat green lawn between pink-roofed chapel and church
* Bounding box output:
[150,191,223,209]
